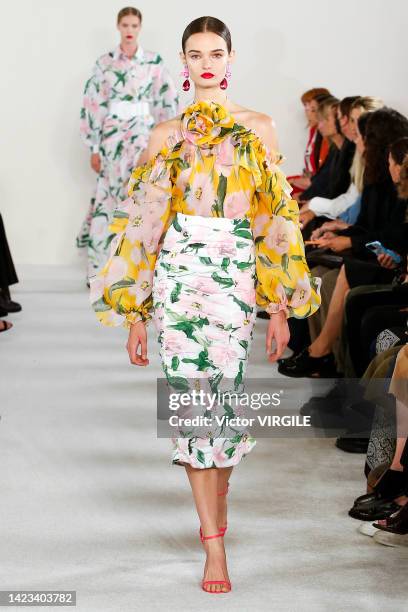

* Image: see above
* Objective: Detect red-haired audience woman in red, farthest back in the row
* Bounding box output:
[287,87,331,195]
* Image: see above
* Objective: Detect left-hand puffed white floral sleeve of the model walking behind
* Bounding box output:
[80,60,109,153]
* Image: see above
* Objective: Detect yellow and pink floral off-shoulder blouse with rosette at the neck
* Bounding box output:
[91,101,320,327]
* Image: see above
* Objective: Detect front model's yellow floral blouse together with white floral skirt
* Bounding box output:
[90,101,320,468]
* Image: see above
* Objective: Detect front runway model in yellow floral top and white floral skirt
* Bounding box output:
[91,17,320,593]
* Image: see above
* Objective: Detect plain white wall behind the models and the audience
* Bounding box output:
[0,0,408,265]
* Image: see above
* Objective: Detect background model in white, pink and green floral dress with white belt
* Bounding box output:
[77,7,179,277]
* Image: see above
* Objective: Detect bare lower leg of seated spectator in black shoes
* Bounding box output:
[309,266,350,357]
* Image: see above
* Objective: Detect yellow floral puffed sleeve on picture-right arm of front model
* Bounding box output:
[253,145,321,319]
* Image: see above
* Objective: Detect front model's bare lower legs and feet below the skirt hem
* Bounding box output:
[185,465,229,592]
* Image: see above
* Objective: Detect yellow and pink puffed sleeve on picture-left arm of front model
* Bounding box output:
[90,147,174,328]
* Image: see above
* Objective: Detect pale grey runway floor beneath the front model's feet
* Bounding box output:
[0,266,407,612]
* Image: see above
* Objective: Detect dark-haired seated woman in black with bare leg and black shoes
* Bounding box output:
[278,108,408,377]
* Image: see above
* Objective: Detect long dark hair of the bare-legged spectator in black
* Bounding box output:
[364,106,408,185]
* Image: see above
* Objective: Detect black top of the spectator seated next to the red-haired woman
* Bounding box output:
[301,138,355,200]
